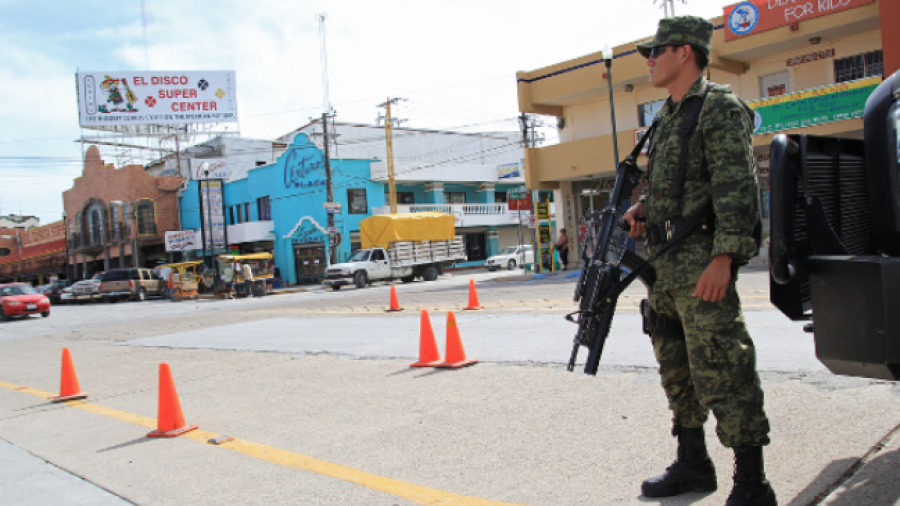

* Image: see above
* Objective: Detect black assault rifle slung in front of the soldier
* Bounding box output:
[566,135,653,375]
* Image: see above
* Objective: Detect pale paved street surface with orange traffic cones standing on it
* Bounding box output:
[0,266,900,505]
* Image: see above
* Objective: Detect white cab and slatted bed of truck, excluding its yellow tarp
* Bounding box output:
[322,236,466,290]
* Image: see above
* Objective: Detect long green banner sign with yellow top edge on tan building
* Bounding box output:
[747,77,881,134]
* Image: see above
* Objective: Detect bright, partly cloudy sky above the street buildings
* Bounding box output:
[0,0,735,223]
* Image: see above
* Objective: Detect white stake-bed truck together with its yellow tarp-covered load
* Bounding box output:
[323,213,466,290]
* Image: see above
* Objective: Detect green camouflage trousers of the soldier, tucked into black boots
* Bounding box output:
[650,279,769,448]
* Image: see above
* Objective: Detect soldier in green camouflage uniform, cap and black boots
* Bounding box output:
[626,16,777,506]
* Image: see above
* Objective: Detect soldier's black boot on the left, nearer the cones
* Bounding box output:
[641,425,718,497]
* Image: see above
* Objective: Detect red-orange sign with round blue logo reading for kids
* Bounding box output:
[725,0,875,42]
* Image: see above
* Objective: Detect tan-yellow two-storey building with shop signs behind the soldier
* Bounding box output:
[517,0,900,258]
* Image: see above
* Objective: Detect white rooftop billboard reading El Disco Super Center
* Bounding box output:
[77,70,237,127]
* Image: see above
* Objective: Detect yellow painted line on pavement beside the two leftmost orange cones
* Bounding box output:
[0,381,517,506]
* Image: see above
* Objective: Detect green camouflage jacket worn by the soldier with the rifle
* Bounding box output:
[642,77,758,292]
